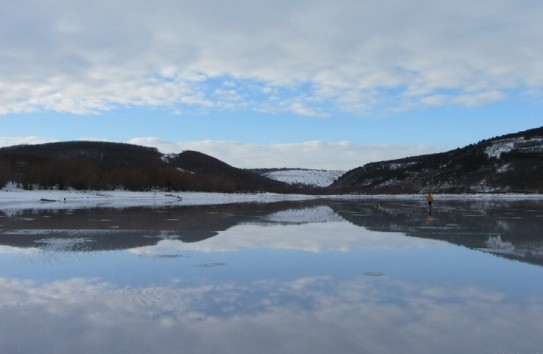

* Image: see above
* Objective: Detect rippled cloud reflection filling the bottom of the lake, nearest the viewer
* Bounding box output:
[0,276,543,353]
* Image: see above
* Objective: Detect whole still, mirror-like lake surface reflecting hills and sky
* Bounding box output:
[0,200,543,354]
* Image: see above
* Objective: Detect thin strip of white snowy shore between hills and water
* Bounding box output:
[0,189,543,210]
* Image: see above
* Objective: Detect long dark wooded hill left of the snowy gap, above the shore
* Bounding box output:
[0,141,294,193]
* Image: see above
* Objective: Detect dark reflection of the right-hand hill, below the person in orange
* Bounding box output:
[335,201,543,265]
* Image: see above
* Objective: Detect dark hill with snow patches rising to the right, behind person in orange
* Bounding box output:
[332,127,543,194]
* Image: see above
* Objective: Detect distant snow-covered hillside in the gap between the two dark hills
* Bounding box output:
[264,169,345,187]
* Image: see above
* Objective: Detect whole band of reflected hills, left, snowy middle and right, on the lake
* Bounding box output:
[0,200,543,265]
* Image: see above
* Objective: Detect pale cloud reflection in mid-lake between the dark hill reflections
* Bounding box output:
[130,222,442,255]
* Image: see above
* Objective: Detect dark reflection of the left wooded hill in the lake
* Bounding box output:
[0,202,332,251]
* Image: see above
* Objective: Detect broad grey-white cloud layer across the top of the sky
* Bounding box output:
[0,0,543,114]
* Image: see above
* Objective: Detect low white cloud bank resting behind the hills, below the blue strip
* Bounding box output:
[129,137,445,170]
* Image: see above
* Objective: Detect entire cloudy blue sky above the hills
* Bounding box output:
[0,0,543,170]
